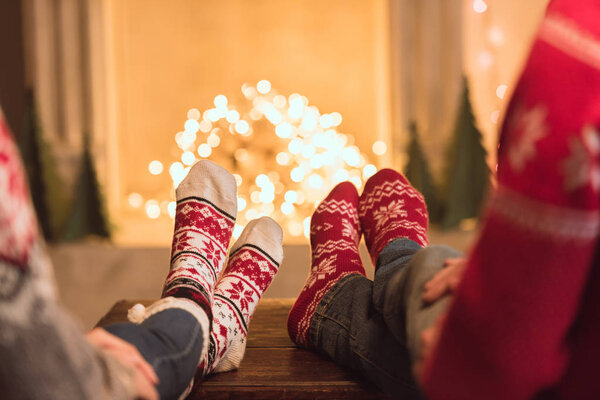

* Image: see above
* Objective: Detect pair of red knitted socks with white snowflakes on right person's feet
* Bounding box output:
[288,169,428,347]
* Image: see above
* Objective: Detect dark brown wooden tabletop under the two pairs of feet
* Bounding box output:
[98,299,388,400]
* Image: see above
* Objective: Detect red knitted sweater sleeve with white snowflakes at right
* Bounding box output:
[423,1,600,400]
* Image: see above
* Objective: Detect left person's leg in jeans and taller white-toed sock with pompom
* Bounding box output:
[106,160,237,398]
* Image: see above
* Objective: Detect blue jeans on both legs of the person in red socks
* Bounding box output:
[309,238,461,399]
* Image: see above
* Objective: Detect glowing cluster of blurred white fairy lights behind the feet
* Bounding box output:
[128,80,387,238]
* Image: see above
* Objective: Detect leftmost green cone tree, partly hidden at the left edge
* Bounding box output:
[18,90,67,241]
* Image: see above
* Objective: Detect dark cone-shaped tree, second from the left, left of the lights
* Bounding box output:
[64,135,110,240]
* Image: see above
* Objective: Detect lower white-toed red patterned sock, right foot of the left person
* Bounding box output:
[199,217,283,376]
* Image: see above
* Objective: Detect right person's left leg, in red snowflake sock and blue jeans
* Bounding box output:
[288,183,418,398]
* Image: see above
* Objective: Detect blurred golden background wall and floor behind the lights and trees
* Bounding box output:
[0,0,548,326]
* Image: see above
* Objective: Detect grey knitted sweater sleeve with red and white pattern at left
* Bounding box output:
[0,110,134,400]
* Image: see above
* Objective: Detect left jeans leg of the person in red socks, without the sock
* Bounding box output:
[310,275,420,399]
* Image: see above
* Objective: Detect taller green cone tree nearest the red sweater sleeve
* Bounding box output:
[442,78,490,228]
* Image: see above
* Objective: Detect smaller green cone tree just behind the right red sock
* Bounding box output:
[404,121,443,223]
